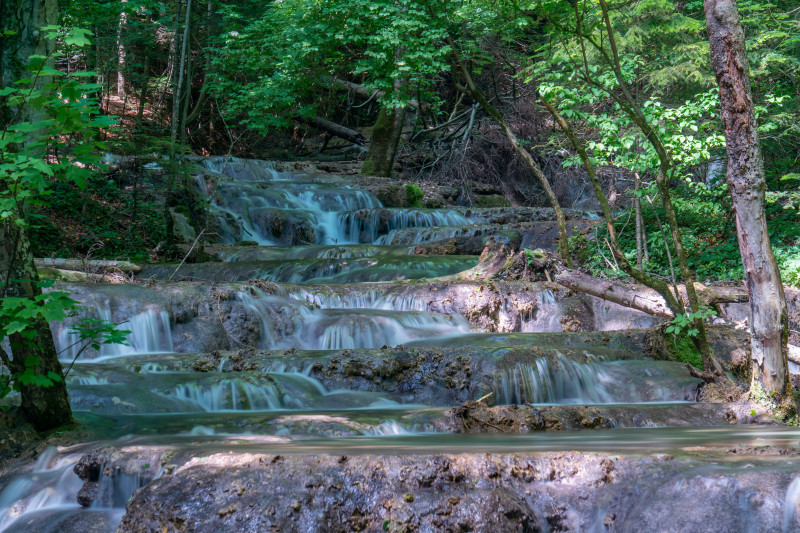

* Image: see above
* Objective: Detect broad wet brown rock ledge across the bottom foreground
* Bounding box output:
[98,446,800,532]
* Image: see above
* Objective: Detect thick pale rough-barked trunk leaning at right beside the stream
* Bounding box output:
[705,0,791,396]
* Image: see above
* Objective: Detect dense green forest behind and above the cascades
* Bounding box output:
[3,0,800,284]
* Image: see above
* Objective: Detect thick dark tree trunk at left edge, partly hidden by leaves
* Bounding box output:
[0,0,72,431]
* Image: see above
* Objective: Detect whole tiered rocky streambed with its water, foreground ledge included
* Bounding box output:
[0,158,800,533]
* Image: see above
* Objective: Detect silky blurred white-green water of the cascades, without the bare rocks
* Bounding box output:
[6,163,800,531]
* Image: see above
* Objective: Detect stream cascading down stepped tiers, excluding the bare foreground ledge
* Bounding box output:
[0,158,800,532]
